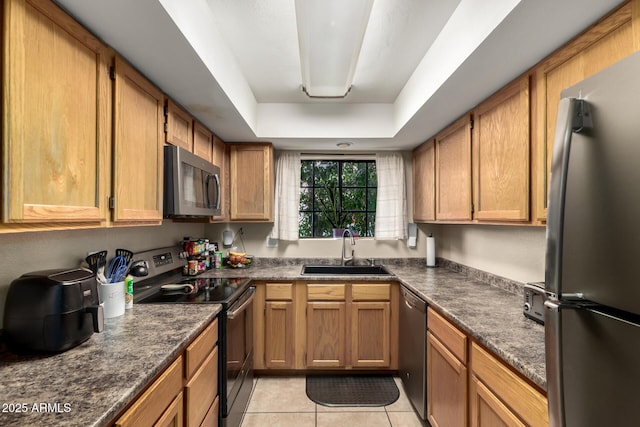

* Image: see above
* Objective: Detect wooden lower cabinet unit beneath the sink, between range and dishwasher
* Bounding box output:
[254,281,398,370]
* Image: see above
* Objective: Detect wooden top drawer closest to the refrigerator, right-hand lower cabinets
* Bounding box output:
[471,343,549,426]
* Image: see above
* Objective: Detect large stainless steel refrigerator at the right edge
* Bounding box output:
[545,54,640,427]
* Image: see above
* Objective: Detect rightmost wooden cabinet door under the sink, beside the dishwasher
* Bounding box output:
[351,301,391,368]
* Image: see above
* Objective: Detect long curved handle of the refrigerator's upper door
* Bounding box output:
[545,98,592,297]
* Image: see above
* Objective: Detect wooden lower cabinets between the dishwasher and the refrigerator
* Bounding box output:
[427,308,549,427]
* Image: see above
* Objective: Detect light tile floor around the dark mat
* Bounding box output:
[242,376,425,427]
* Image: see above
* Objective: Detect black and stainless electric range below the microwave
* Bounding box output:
[133,246,255,427]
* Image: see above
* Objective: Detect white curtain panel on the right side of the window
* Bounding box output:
[375,152,407,240]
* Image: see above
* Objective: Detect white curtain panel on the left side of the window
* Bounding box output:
[270,151,300,240]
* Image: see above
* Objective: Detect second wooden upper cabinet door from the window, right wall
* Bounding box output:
[435,116,471,221]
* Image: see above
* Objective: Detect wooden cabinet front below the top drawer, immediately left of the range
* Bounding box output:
[185,347,218,427]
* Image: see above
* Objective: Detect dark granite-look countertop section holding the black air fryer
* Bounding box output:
[0,304,221,427]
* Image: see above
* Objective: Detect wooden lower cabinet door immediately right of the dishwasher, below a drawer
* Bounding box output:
[427,333,467,427]
